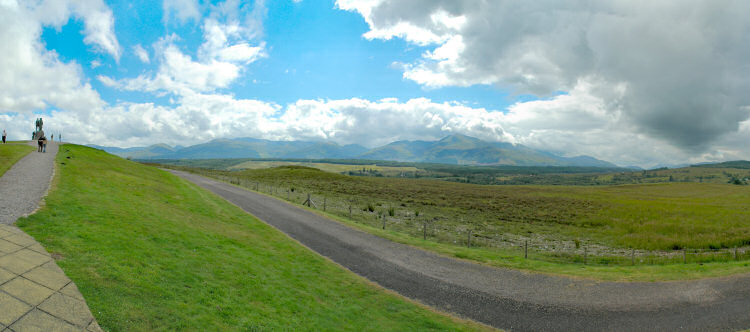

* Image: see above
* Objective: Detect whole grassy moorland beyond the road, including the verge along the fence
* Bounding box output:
[159,167,750,281]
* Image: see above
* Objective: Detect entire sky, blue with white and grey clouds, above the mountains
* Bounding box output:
[0,0,750,167]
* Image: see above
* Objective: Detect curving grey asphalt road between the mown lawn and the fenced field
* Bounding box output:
[170,171,750,331]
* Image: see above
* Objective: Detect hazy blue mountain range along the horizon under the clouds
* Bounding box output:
[89,135,617,167]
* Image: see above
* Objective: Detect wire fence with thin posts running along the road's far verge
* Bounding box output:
[179,165,750,265]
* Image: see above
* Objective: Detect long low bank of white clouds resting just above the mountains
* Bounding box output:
[5,92,750,167]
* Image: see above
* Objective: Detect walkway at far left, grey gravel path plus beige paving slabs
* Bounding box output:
[0,143,101,332]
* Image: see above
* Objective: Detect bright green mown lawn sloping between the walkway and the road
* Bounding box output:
[18,145,485,331]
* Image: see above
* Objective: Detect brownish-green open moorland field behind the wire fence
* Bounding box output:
[176,167,750,250]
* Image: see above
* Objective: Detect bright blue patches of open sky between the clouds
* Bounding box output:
[42,1,524,111]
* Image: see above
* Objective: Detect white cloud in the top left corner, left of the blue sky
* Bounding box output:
[0,0,107,113]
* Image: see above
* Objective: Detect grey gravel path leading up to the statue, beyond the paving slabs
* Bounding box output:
[0,142,58,224]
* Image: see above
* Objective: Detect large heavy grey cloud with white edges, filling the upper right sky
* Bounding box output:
[337,0,750,152]
